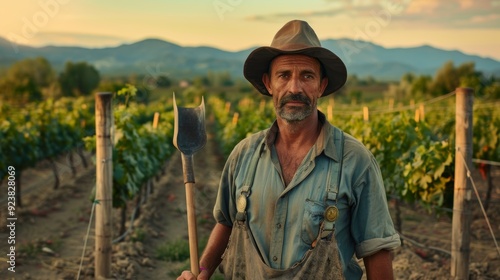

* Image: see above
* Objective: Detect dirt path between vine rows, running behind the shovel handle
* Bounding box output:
[129,130,224,279]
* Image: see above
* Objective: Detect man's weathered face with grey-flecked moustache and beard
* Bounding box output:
[262,55,328,122]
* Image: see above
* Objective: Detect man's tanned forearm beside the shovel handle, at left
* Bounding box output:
[200,223,231,276]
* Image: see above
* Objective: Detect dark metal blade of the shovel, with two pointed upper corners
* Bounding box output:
[173,94,207,155]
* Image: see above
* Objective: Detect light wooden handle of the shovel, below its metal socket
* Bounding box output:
[185,182,200,276]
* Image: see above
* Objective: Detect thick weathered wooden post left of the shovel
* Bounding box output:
[94,92,114,279]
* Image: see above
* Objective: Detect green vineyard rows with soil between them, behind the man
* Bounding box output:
[0,85,500,279]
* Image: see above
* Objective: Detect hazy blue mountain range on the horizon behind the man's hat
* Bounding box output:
[0,35,500,80]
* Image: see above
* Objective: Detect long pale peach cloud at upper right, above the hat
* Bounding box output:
[246,0,500,29]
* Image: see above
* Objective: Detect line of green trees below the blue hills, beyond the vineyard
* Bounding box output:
[0,57,500,105]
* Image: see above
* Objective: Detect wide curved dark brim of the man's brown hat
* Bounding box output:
[243,47,347,97]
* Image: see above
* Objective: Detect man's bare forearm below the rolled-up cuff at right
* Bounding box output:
[363,250,394,280]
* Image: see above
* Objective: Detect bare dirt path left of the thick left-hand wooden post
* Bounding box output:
[0,152,95,279]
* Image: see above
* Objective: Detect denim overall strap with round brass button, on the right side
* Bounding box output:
[321,127,344,237]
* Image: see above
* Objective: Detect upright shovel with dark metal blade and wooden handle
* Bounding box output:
[173,93,207,276]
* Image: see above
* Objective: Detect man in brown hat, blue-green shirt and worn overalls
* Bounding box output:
[178,20,400,280]
